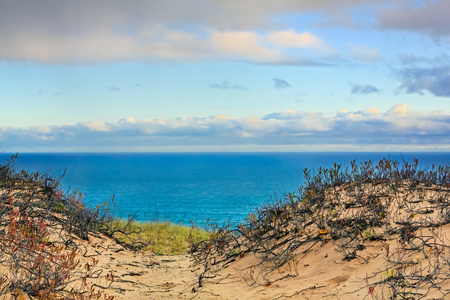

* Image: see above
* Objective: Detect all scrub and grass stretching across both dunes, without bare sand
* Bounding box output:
[0,156,450,299]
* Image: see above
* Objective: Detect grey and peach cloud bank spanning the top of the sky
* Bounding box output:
[0,0,450,65]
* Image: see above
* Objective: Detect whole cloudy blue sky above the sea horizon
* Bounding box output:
[0,0,450,152]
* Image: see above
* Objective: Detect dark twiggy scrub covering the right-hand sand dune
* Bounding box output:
[191,159,450,299]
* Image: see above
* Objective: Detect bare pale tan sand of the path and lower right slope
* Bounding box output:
[0,182,450,300]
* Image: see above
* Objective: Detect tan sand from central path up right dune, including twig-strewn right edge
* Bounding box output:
[72,179,450,299]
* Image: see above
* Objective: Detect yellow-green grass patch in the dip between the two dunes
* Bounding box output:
[110,220,207,255]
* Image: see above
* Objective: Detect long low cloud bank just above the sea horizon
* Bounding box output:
[0,104,450,152]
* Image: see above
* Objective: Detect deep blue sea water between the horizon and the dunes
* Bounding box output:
[0,152,450,226]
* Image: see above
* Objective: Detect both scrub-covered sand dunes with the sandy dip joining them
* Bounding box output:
[0,160,450,300]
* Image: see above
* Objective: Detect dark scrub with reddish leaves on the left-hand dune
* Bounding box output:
[0,155,113,299]
